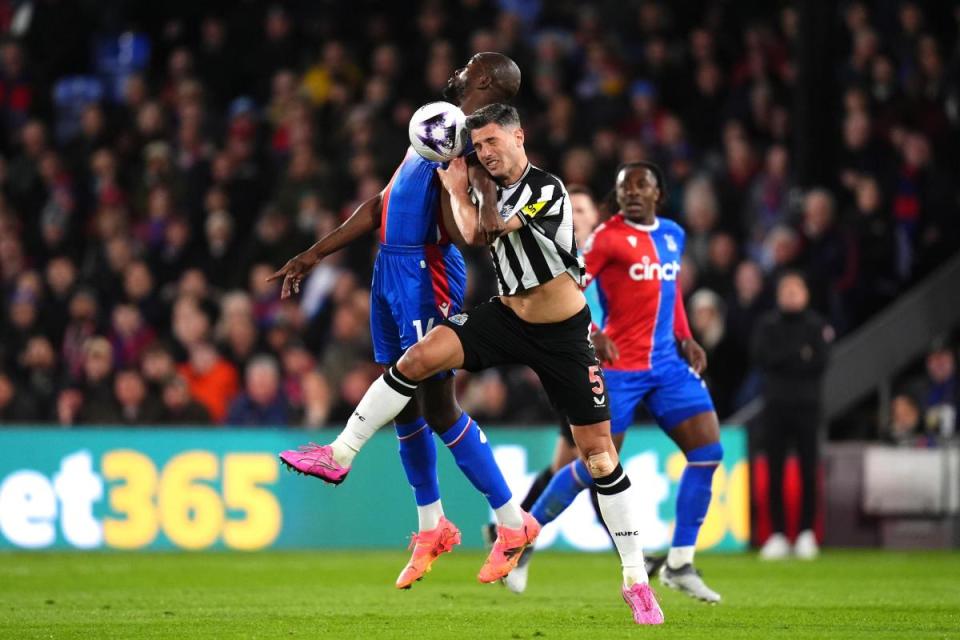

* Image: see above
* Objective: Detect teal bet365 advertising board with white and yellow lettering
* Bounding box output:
[0,427,750,551]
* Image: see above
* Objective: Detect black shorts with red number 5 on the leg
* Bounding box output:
[444,298,610,426]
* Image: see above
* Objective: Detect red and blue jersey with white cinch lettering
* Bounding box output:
[584,213,690,371]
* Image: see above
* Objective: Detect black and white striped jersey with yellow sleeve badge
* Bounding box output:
[490,164,586,296]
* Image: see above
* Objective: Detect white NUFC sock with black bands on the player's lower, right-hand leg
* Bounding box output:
[594,464,650,587]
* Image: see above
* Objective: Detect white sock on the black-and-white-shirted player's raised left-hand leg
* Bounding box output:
[330,367,416,467]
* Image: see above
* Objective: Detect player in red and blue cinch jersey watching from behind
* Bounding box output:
[524,162,723,602]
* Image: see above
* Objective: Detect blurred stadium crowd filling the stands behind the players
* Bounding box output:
[0,0,960,436]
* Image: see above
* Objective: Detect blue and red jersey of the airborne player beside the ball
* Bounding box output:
[380,147,450,247]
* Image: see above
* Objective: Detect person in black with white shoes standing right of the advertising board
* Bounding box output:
[753,272,833,560]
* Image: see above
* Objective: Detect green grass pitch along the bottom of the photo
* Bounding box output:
[0,551,960,640]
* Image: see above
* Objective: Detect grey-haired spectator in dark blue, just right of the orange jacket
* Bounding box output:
[227,356,291,427]
